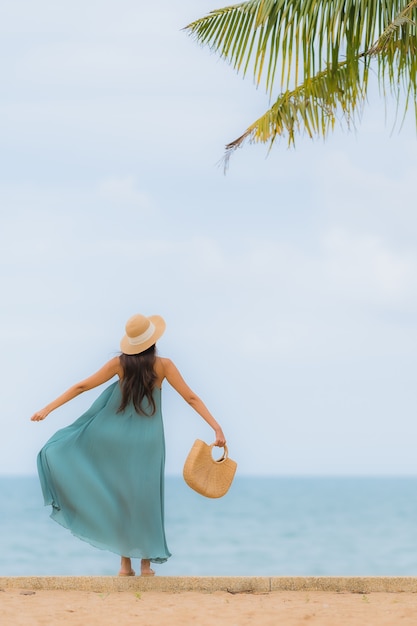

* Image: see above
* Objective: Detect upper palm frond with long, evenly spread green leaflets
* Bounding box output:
[185,0,416,94]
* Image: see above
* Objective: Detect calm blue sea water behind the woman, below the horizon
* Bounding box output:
[0,476,417,576]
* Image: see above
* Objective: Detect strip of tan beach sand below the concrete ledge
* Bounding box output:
[0,588,417,626]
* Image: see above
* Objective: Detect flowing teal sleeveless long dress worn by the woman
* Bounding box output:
[38,382,171,563]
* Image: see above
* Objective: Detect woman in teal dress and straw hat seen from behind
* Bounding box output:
[31,315,226,576]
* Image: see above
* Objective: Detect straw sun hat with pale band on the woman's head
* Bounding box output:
[120,314,166,354]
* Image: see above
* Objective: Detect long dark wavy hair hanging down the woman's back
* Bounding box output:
[117,344,157,415]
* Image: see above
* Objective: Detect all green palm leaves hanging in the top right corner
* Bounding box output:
[186,0,417,165]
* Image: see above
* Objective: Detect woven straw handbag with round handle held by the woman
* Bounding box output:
[183,439,237,498]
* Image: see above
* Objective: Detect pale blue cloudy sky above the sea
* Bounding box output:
[0,0,417,475]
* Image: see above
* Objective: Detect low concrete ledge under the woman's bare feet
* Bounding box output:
[0,576,417,593]
